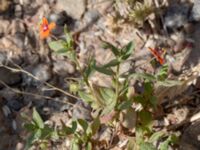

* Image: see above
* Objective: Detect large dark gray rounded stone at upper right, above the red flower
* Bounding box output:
[164,4,189,29]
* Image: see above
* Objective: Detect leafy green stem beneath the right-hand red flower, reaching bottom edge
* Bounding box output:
[125,65,180,150]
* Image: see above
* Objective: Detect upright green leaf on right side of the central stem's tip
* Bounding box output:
[121,42,134,60]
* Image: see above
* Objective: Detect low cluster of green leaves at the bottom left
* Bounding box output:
[24,108,100,150]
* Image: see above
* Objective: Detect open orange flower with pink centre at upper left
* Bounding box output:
[40,17,56,39]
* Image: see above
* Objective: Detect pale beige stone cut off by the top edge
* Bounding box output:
[56,0,86,19]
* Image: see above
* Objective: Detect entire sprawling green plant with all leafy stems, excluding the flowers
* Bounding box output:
[23,30,180,150]
